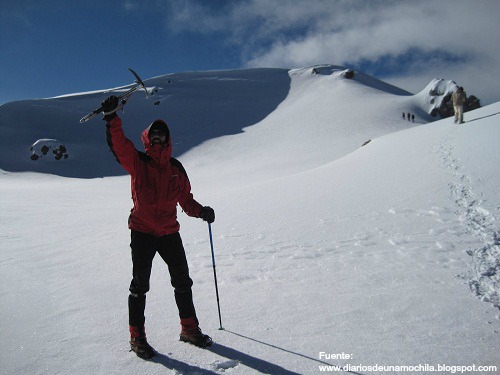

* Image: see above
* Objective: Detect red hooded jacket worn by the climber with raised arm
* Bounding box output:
[106,116,202,237]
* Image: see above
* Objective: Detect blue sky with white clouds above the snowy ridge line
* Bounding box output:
[0,0,500,104]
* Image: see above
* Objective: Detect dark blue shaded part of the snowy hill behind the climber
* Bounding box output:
[0,69,290,177]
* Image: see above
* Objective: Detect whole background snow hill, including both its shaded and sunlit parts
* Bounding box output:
[0,66,431,177]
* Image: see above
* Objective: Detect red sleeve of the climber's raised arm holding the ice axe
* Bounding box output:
[106,116,138,176]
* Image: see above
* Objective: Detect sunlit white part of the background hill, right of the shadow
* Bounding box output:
[183,66,431,184]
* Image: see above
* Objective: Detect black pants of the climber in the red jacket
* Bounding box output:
[128,230,196,327]
